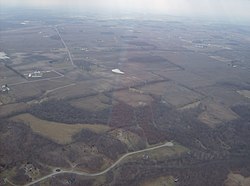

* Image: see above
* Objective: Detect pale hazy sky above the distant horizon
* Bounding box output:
[0,0,250,19]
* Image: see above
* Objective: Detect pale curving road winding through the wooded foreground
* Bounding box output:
[25,142,174,186]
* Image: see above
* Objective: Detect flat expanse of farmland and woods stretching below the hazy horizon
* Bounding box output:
[0,11,250,186]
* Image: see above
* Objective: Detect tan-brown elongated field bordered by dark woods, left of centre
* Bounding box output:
[12,114,109,144]
